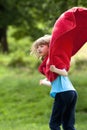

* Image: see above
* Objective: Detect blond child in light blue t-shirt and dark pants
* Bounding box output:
[31,35,77,130]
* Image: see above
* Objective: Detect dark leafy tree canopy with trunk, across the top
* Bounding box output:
[0,0,87,52]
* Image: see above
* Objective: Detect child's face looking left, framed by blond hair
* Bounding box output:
[37,45,49,57]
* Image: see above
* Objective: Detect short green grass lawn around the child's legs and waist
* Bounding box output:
[0,66,87,130]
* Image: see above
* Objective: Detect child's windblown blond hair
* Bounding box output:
[30,34,51,58]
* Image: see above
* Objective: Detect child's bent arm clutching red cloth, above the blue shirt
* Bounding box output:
[50,65,68,76]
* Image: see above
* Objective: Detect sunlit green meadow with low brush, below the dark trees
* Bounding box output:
[0,25,87,130]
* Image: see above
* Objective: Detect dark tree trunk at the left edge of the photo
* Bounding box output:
[0,27,8,53]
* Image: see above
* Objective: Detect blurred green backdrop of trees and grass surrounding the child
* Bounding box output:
[0,0,87,130]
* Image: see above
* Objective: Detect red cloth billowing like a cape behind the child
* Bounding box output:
[45,7,87,81]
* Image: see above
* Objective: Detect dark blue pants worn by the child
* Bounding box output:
[49,91,77,130]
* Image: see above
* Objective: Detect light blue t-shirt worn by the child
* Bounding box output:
[50,76,75,98]
